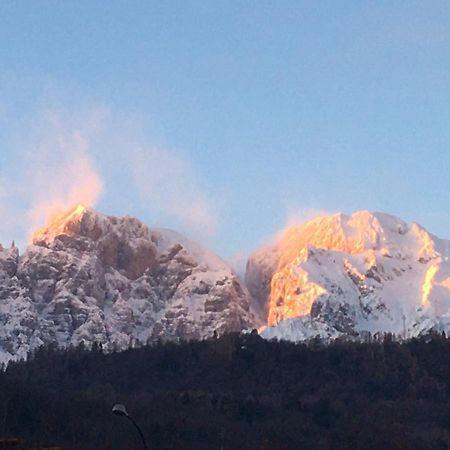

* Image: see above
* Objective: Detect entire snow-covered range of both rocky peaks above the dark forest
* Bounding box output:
[0,206,450,362]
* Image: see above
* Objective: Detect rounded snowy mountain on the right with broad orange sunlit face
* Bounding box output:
[245,211,450,340]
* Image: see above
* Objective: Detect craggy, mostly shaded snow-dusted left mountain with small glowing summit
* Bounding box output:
[0,205,254,362]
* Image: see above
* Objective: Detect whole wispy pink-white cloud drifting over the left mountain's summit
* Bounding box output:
[0,95,218,248]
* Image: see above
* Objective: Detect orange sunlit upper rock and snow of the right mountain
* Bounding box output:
[267,211,444,325]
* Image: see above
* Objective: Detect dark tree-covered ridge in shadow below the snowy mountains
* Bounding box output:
[0,334,450,450]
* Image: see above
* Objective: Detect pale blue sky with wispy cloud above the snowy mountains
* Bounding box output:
[0,0,450,260]
